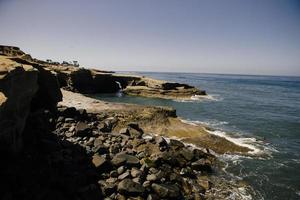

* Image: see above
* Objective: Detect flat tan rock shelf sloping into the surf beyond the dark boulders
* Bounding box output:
[59,90,251,155]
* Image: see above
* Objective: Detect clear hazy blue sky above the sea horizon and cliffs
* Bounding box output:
[0,0,300,75]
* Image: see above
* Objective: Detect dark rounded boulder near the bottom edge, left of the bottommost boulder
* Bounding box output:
[118,179,145,196]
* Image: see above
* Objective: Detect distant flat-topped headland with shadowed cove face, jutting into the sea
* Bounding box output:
[48,66,206,99]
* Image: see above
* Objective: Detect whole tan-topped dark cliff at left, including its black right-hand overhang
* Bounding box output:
[0,56,62,153]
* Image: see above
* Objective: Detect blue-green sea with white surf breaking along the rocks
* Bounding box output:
[98,72,300,199]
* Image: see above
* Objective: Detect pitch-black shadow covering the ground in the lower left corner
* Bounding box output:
[0,111,102,200]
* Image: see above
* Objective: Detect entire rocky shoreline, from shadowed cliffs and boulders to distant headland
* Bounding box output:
[0,46,250,200]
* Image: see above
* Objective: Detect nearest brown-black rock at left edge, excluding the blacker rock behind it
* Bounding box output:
[0,59,38,152]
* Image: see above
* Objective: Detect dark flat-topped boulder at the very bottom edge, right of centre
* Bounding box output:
[151,183,180,198]
